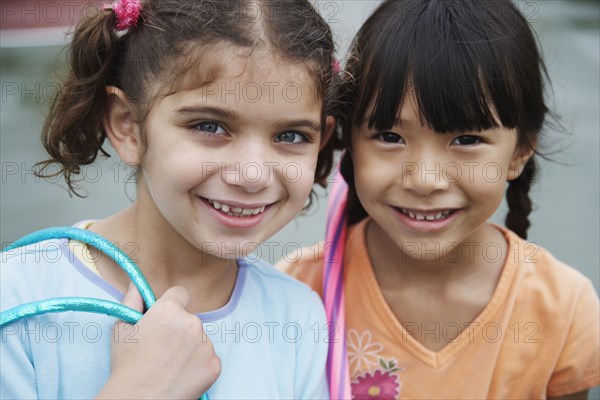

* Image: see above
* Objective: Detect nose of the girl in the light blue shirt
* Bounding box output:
[221,142,277,193]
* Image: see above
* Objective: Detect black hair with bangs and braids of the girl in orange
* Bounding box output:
[336,0,548,238]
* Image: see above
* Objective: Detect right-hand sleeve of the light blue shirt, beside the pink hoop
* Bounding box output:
[294,292,329,400]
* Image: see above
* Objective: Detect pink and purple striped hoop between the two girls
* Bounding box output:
[323,168,352,399]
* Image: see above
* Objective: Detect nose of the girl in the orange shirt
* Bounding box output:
[401,151,450,196]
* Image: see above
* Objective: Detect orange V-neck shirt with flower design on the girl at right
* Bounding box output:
[280,220,600,399]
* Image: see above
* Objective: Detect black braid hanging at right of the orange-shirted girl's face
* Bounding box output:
[505,157,537,239]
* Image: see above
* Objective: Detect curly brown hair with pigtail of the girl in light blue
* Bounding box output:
[37,0,336,205]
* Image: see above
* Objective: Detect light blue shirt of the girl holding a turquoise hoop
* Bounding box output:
[0,239,328,399]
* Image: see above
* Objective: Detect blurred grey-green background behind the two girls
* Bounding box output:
[0,0,600,398]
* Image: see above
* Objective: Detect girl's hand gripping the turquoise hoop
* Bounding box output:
[97,285,221,399]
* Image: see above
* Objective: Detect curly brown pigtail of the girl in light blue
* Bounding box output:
[36,10,120,197]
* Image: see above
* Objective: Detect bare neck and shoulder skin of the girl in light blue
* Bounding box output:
[90,205,237,313]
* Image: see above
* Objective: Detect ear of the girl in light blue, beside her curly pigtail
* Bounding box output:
[103,86,142,165]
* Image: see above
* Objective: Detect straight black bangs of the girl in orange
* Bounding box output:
[350,0,541,133]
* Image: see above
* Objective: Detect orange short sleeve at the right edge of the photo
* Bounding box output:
[547,280,600,397]
